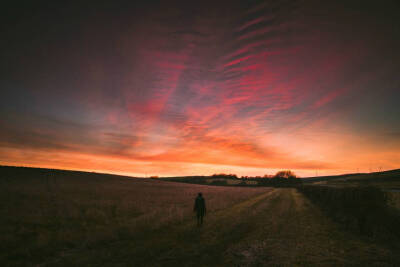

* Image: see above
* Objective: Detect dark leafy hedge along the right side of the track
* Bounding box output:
[298,185,400,244]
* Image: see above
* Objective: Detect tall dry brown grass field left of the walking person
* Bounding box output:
[0,169,267,264]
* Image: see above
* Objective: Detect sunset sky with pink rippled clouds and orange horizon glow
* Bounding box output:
[0,0,400,177]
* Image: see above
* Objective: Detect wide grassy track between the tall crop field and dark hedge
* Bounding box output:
[46,189,398,266]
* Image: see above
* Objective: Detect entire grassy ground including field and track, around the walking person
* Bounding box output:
[0,167,400,266]
